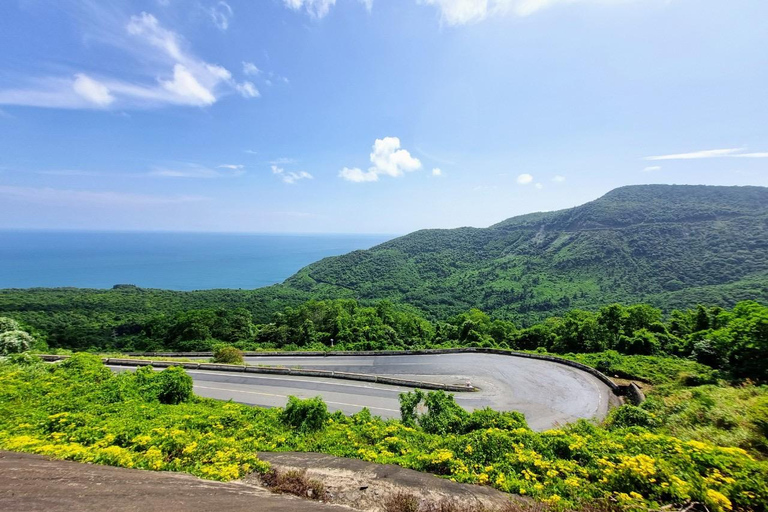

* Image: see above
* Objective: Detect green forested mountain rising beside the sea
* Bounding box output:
[285,185,768,323]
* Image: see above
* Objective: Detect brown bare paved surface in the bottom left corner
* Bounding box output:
[0,451,349,512]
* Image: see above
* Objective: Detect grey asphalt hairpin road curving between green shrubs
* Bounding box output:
[123,353,615,430]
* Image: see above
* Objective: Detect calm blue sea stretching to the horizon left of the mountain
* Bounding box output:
[0,231,395,290]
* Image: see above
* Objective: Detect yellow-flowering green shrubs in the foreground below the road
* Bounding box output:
[0,355,768,512]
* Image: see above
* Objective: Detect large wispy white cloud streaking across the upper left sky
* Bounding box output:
[0,2,259,109]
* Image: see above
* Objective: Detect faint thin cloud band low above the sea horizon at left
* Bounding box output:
[0,185,208,206]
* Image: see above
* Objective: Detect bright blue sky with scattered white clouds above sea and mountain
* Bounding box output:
[0,0,768,233]
